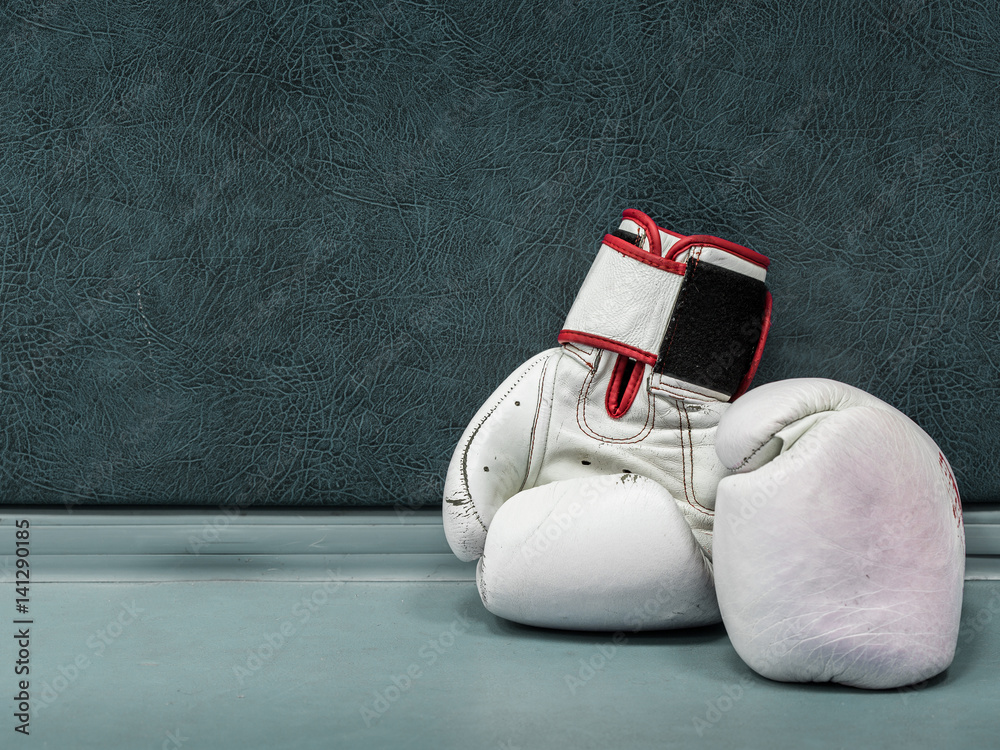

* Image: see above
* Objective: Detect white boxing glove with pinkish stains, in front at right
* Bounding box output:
[715,379,965,688]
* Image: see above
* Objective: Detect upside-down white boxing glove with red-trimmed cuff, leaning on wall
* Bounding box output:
[444,209,770,630]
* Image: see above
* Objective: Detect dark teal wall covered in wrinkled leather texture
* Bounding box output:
[0,0,1000,505]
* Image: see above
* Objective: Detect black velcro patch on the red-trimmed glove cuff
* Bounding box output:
[653,260,767,396]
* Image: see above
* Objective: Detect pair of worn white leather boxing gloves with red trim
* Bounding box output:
[443,209,965,688]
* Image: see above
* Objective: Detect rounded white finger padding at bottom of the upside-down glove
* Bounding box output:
[477,474,720,631]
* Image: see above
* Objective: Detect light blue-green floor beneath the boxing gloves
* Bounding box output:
[0,581,1000,750]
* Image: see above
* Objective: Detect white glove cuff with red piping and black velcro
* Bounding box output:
[559,209,771,401]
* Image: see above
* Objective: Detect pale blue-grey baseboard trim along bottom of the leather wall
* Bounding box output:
[0,506,1000,583]
